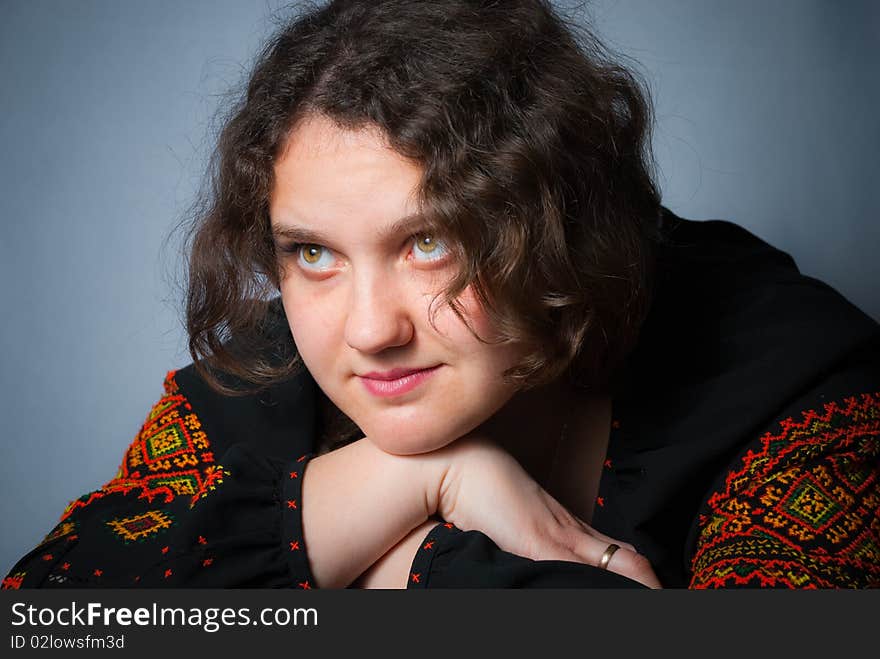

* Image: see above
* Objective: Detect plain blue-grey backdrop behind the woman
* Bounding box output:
[0,0,880,574]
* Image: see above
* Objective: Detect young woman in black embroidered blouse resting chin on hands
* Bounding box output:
[4,0,880,588]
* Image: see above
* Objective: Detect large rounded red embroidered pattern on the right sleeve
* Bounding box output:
[690,392,880,588]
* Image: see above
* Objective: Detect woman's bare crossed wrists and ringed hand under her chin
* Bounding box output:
[304,436,659,588]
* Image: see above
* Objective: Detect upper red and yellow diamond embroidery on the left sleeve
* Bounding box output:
[61,371,229,521]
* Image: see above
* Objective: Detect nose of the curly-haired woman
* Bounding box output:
[345,275,414,354]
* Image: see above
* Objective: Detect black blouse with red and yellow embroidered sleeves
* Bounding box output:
[3,212,880,588]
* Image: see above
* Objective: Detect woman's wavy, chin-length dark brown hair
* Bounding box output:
[186,0,660,393]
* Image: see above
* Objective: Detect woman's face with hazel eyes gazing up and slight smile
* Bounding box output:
[270,116,521,454]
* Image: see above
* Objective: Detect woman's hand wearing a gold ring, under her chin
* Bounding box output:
[437,437,661,588]
